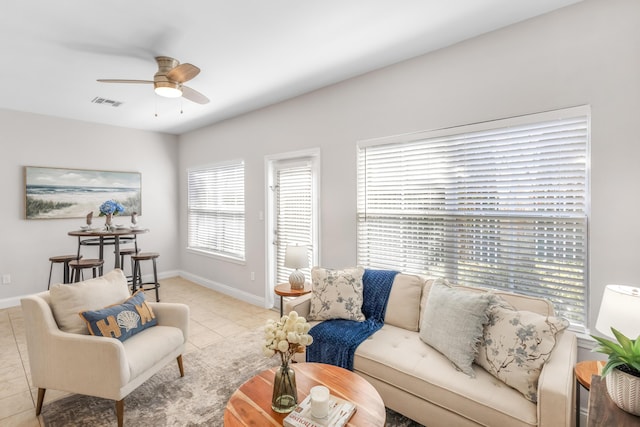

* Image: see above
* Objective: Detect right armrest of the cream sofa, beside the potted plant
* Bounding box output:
[538,331,578,427]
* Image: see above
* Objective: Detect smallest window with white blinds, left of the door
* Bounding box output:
[187,161,245,261]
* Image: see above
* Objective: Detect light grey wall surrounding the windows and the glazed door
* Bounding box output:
[179,0,640,338]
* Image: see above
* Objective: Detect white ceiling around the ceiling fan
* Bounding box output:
[0,0,580,134]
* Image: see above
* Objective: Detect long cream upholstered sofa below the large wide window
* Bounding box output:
[285,274,577,427]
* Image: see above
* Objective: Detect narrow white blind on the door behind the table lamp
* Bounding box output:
[275,161,313,283]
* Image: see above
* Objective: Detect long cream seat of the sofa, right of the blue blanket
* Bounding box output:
[354,325,538,427]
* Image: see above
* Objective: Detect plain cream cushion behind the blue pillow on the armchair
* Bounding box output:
[49,269,131,335]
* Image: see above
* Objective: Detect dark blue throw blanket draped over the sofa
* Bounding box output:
[306,269,398,371]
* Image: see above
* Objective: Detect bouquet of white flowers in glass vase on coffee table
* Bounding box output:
[262,311,313,365]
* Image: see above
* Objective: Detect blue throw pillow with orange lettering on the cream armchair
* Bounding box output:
[80,291,158,341]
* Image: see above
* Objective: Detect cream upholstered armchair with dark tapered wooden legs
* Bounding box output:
[21,270,189,426]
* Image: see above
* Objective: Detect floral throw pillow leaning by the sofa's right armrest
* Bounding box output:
[475,299,569,403]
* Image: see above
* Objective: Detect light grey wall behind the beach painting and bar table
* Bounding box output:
[0,110,179,308]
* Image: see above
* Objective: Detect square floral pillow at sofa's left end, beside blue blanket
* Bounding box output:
[307,267,365,322]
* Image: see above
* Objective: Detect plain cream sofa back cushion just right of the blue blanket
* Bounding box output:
[384,273,424,331]
